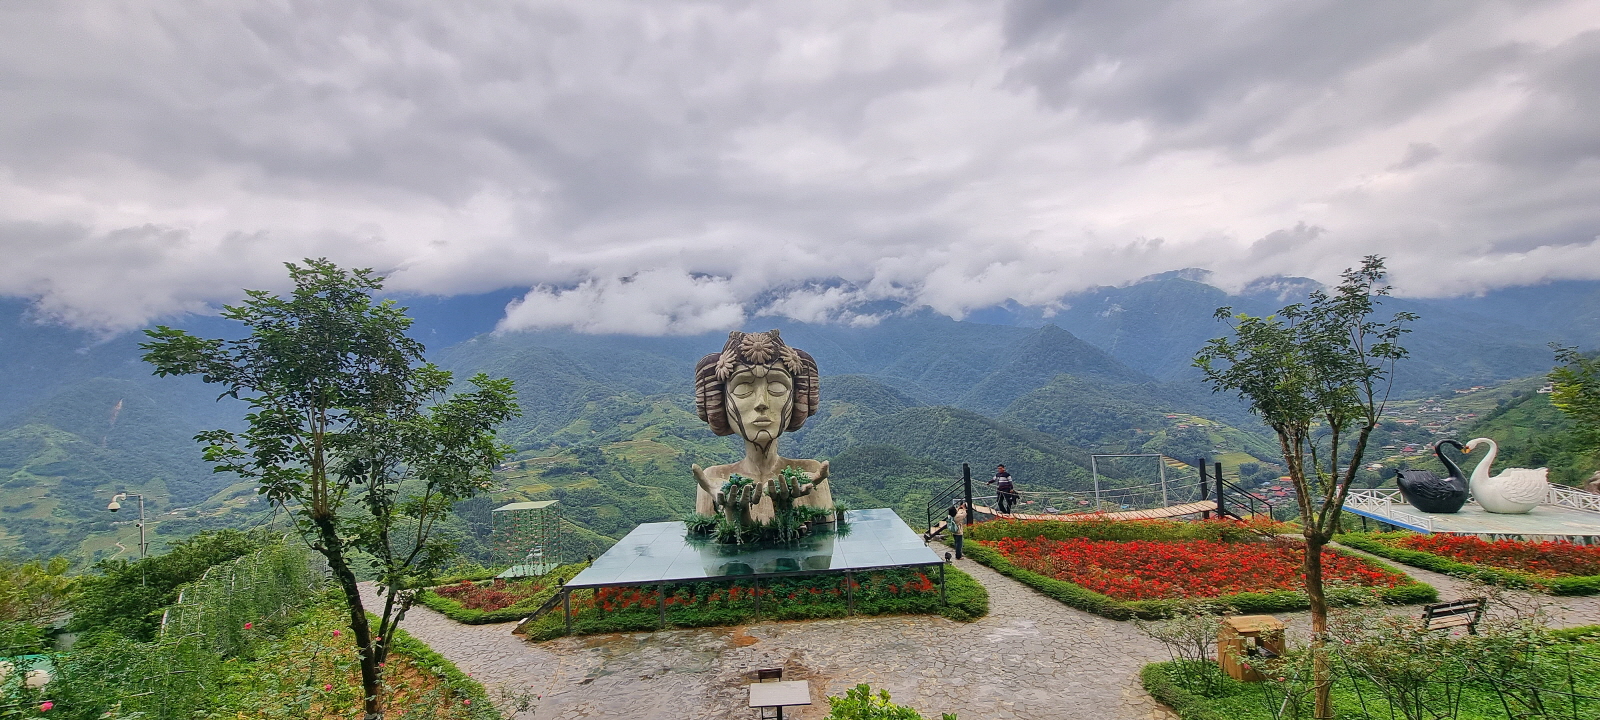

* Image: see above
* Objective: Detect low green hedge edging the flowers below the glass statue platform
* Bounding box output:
[518,565,989,642]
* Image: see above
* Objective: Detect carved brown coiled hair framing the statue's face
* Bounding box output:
[694,330,818,435]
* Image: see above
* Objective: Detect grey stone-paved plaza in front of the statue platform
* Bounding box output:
[371,547,1600,720]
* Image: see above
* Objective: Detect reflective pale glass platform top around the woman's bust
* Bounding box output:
[566,509,941,587]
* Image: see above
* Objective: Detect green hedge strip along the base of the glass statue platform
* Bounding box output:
[518,566,989,640]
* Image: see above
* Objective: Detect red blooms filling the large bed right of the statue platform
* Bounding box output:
[984,538,1408,600]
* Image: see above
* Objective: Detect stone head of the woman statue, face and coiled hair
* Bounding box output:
[694,330,818,446]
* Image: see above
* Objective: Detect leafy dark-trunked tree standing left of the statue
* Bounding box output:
[141,259,518,720]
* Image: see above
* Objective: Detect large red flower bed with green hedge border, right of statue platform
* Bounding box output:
[968,522,1438,619]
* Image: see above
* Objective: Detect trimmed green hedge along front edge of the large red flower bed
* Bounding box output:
[963,542,1438,619]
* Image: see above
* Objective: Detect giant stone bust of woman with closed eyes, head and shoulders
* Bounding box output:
[693,330,834,525]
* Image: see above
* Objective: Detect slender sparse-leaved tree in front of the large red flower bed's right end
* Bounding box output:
[1195,256,1416,718]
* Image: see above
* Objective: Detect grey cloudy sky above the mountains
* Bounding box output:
[0,0,1600,333]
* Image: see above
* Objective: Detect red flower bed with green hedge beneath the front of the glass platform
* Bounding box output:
[518,566,989,640]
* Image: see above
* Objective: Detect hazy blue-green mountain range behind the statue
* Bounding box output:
[0,272,1600,560]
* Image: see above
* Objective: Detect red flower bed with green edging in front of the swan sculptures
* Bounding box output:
[1334,531,1600,595]
